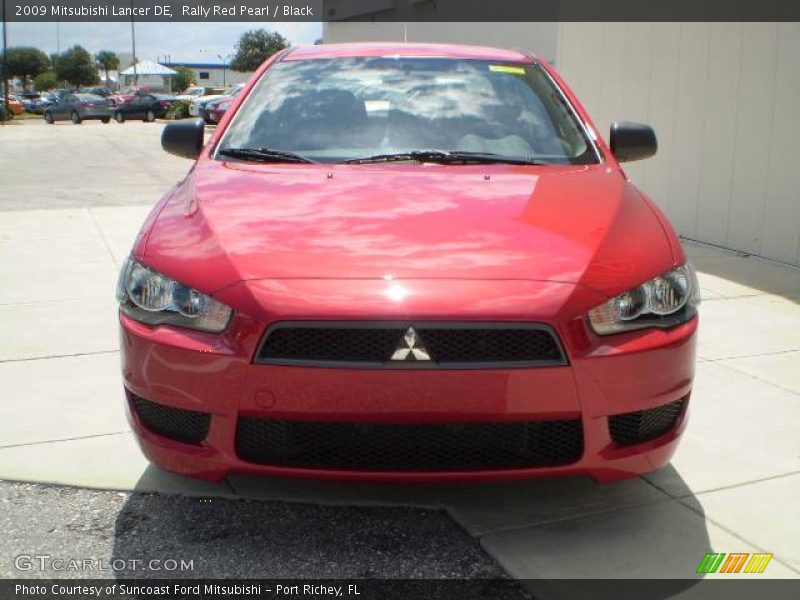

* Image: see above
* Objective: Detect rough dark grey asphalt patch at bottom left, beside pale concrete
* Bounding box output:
[0,482,526,598]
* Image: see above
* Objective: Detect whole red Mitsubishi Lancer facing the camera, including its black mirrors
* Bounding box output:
[118,44,698,482]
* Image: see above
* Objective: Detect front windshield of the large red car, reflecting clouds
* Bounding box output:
[219,57,598,164]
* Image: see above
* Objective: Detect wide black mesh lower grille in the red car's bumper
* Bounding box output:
[236,417,583,471]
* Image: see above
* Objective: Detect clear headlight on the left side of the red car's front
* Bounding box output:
[117,257,232,333]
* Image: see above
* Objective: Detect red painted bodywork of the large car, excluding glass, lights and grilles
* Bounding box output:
[120,44,697,481]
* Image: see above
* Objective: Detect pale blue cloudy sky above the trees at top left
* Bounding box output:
[0,22,322,62]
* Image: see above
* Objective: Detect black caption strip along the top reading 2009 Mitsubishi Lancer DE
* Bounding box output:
[0,0,800,22]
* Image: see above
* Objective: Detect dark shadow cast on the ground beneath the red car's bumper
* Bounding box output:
[113,466,712,600]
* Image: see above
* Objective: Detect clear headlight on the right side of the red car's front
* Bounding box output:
[589,262,700,335]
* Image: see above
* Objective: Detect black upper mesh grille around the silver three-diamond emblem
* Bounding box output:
[256,322,566,368]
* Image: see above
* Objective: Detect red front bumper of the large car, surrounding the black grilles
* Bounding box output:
[120,283,697,482]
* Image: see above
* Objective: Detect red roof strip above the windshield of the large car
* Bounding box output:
[281,43,535,63]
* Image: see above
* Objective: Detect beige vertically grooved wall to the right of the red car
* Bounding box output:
[556,23,800,264]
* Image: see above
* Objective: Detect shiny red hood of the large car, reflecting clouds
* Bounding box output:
[142,159,674,295]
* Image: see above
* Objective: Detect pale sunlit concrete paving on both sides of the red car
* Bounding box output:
[0,123,800,597]
